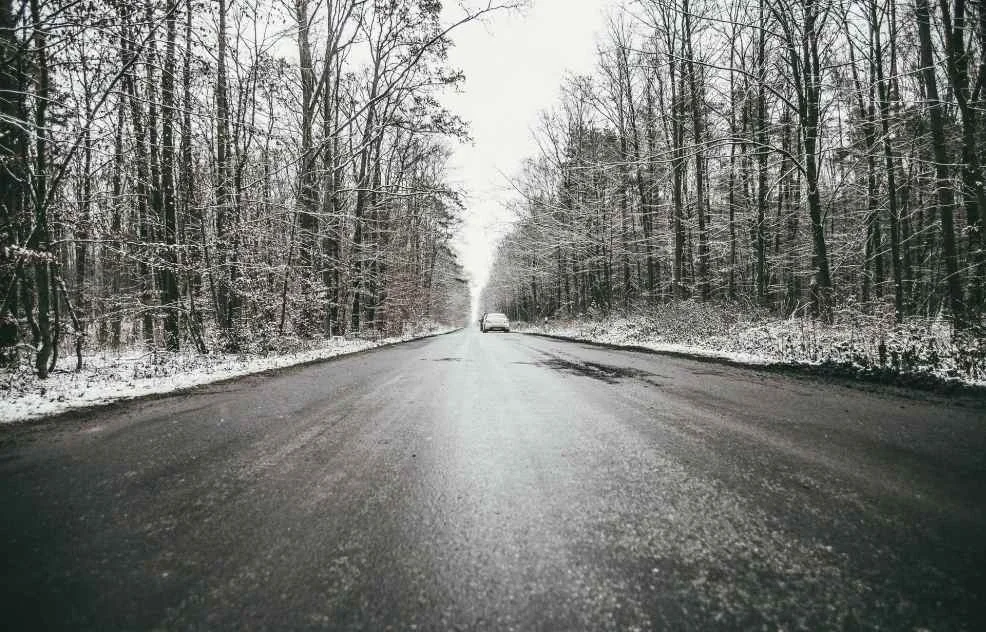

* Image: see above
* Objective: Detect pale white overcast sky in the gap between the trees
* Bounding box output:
[442,0,616,302]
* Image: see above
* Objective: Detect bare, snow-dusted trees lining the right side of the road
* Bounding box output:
[482,0,986,329]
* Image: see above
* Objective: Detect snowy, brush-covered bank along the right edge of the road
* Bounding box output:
[514,301,986,391]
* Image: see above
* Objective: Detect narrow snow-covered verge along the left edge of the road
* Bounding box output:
[0,327,453,423]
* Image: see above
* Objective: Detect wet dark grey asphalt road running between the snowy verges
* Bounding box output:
[0,329,986,630]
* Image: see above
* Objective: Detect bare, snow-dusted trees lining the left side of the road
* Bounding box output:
[0,0,478,378]
